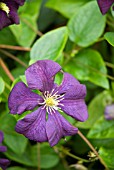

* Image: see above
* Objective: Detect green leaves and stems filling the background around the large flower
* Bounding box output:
[0,0,114,170]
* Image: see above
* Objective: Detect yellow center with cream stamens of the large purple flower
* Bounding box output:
[41,89,64,114]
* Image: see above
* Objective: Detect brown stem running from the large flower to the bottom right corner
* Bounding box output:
[78,130,109,170]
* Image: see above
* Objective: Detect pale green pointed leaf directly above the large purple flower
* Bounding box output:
[30,27,68,62]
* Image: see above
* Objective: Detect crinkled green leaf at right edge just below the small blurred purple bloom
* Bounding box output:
[87,116,114,139]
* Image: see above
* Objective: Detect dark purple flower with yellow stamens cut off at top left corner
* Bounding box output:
[0,0,25,30]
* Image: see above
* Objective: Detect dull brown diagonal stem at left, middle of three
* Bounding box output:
[0,50,27,68]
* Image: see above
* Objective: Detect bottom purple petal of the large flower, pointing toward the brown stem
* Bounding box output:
[46,111,78,146]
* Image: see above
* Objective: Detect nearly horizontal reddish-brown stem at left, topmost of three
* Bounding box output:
[0,44,31,51]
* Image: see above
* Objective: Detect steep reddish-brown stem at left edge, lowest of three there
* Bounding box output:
[0,58,14,81]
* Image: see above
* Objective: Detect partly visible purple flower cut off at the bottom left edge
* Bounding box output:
[0,131,10,170]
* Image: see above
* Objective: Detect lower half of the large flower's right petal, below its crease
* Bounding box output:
[60,99,88,122]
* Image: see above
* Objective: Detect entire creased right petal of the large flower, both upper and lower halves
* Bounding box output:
[58,73,88,121]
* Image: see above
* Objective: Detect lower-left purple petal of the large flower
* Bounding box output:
[15,107,47,142]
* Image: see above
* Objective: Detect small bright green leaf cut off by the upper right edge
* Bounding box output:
[104,32,114,47]
